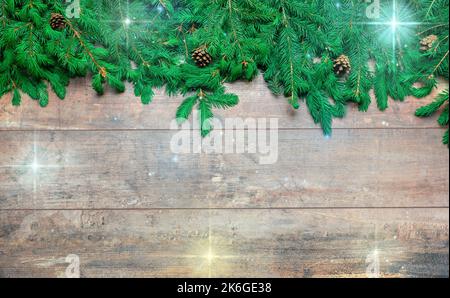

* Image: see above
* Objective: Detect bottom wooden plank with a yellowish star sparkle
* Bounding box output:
[0,209,449,277]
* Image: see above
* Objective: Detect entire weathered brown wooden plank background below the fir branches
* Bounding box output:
[0,78,449,277]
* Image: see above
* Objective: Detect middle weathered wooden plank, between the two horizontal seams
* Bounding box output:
[0,129,449,209]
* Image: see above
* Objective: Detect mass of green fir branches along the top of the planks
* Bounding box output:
[0,0,449,139]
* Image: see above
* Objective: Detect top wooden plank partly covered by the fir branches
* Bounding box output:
[0,77,448,130]
